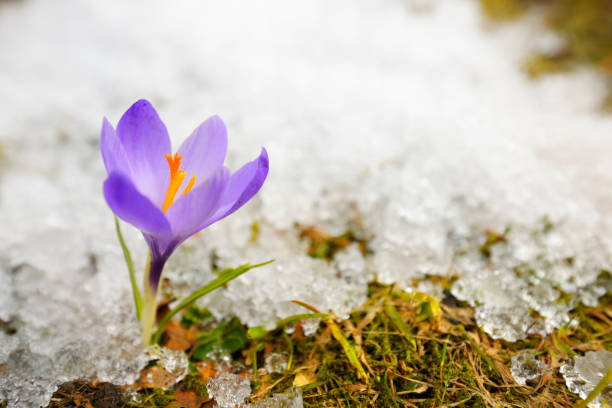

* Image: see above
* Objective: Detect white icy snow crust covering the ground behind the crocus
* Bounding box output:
[0,0,612,407]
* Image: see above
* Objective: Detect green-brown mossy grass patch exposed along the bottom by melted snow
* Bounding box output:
[91,280,612,408]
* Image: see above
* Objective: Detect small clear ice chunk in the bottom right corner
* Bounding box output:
[559,350,612,408]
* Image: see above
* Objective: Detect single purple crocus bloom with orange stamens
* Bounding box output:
[100,100,268,294]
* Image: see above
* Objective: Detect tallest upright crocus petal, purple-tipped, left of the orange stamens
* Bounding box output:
[117,99,171,208]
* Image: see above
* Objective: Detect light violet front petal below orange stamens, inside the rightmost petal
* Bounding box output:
[166,167,229,245]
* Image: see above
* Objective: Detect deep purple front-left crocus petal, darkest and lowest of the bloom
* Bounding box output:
[104,172,170,235]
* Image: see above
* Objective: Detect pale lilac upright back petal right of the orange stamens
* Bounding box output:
[178,115,227,185]
